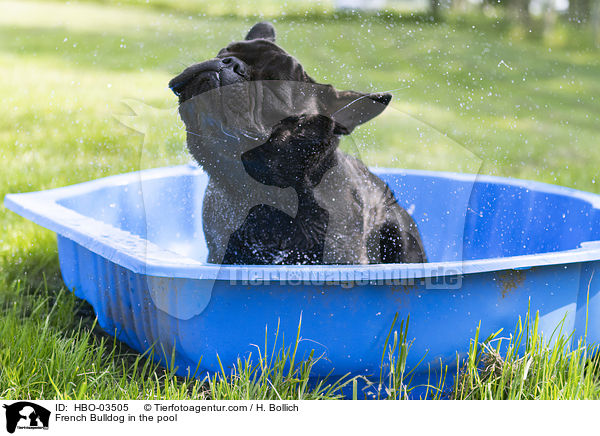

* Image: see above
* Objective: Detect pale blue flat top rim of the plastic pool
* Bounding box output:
[4,164,600,283]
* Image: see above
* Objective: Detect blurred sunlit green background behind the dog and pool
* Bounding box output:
[0,0,600,395]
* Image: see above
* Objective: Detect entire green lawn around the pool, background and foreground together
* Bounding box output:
[0,0,600,398]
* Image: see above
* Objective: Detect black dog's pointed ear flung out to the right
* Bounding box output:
[330,91,392,135]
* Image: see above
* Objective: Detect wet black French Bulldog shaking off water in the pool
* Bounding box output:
[169,23,426,264]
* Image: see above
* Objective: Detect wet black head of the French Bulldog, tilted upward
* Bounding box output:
[169,23,391,176]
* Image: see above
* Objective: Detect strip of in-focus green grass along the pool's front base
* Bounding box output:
[0,281,600,400]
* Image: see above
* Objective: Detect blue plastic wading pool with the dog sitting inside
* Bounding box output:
[5,165,600,390]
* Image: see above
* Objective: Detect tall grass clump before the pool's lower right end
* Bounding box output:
[450,314,600,400]
